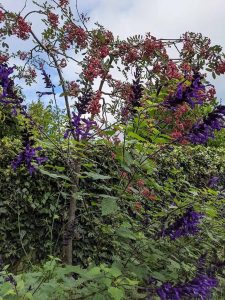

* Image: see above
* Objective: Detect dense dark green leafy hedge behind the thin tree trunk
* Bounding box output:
[0,138,225,268]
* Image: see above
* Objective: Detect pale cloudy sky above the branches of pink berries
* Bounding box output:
[0,0,225,101]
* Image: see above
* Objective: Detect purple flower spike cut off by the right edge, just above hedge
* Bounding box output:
[187,105,225,144]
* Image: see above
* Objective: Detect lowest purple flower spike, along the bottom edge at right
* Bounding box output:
[156,275,218,300]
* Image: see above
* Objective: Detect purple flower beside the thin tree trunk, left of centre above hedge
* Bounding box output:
[64,112,97,140]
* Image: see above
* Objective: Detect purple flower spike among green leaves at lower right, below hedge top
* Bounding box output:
[161,208,203,240]
